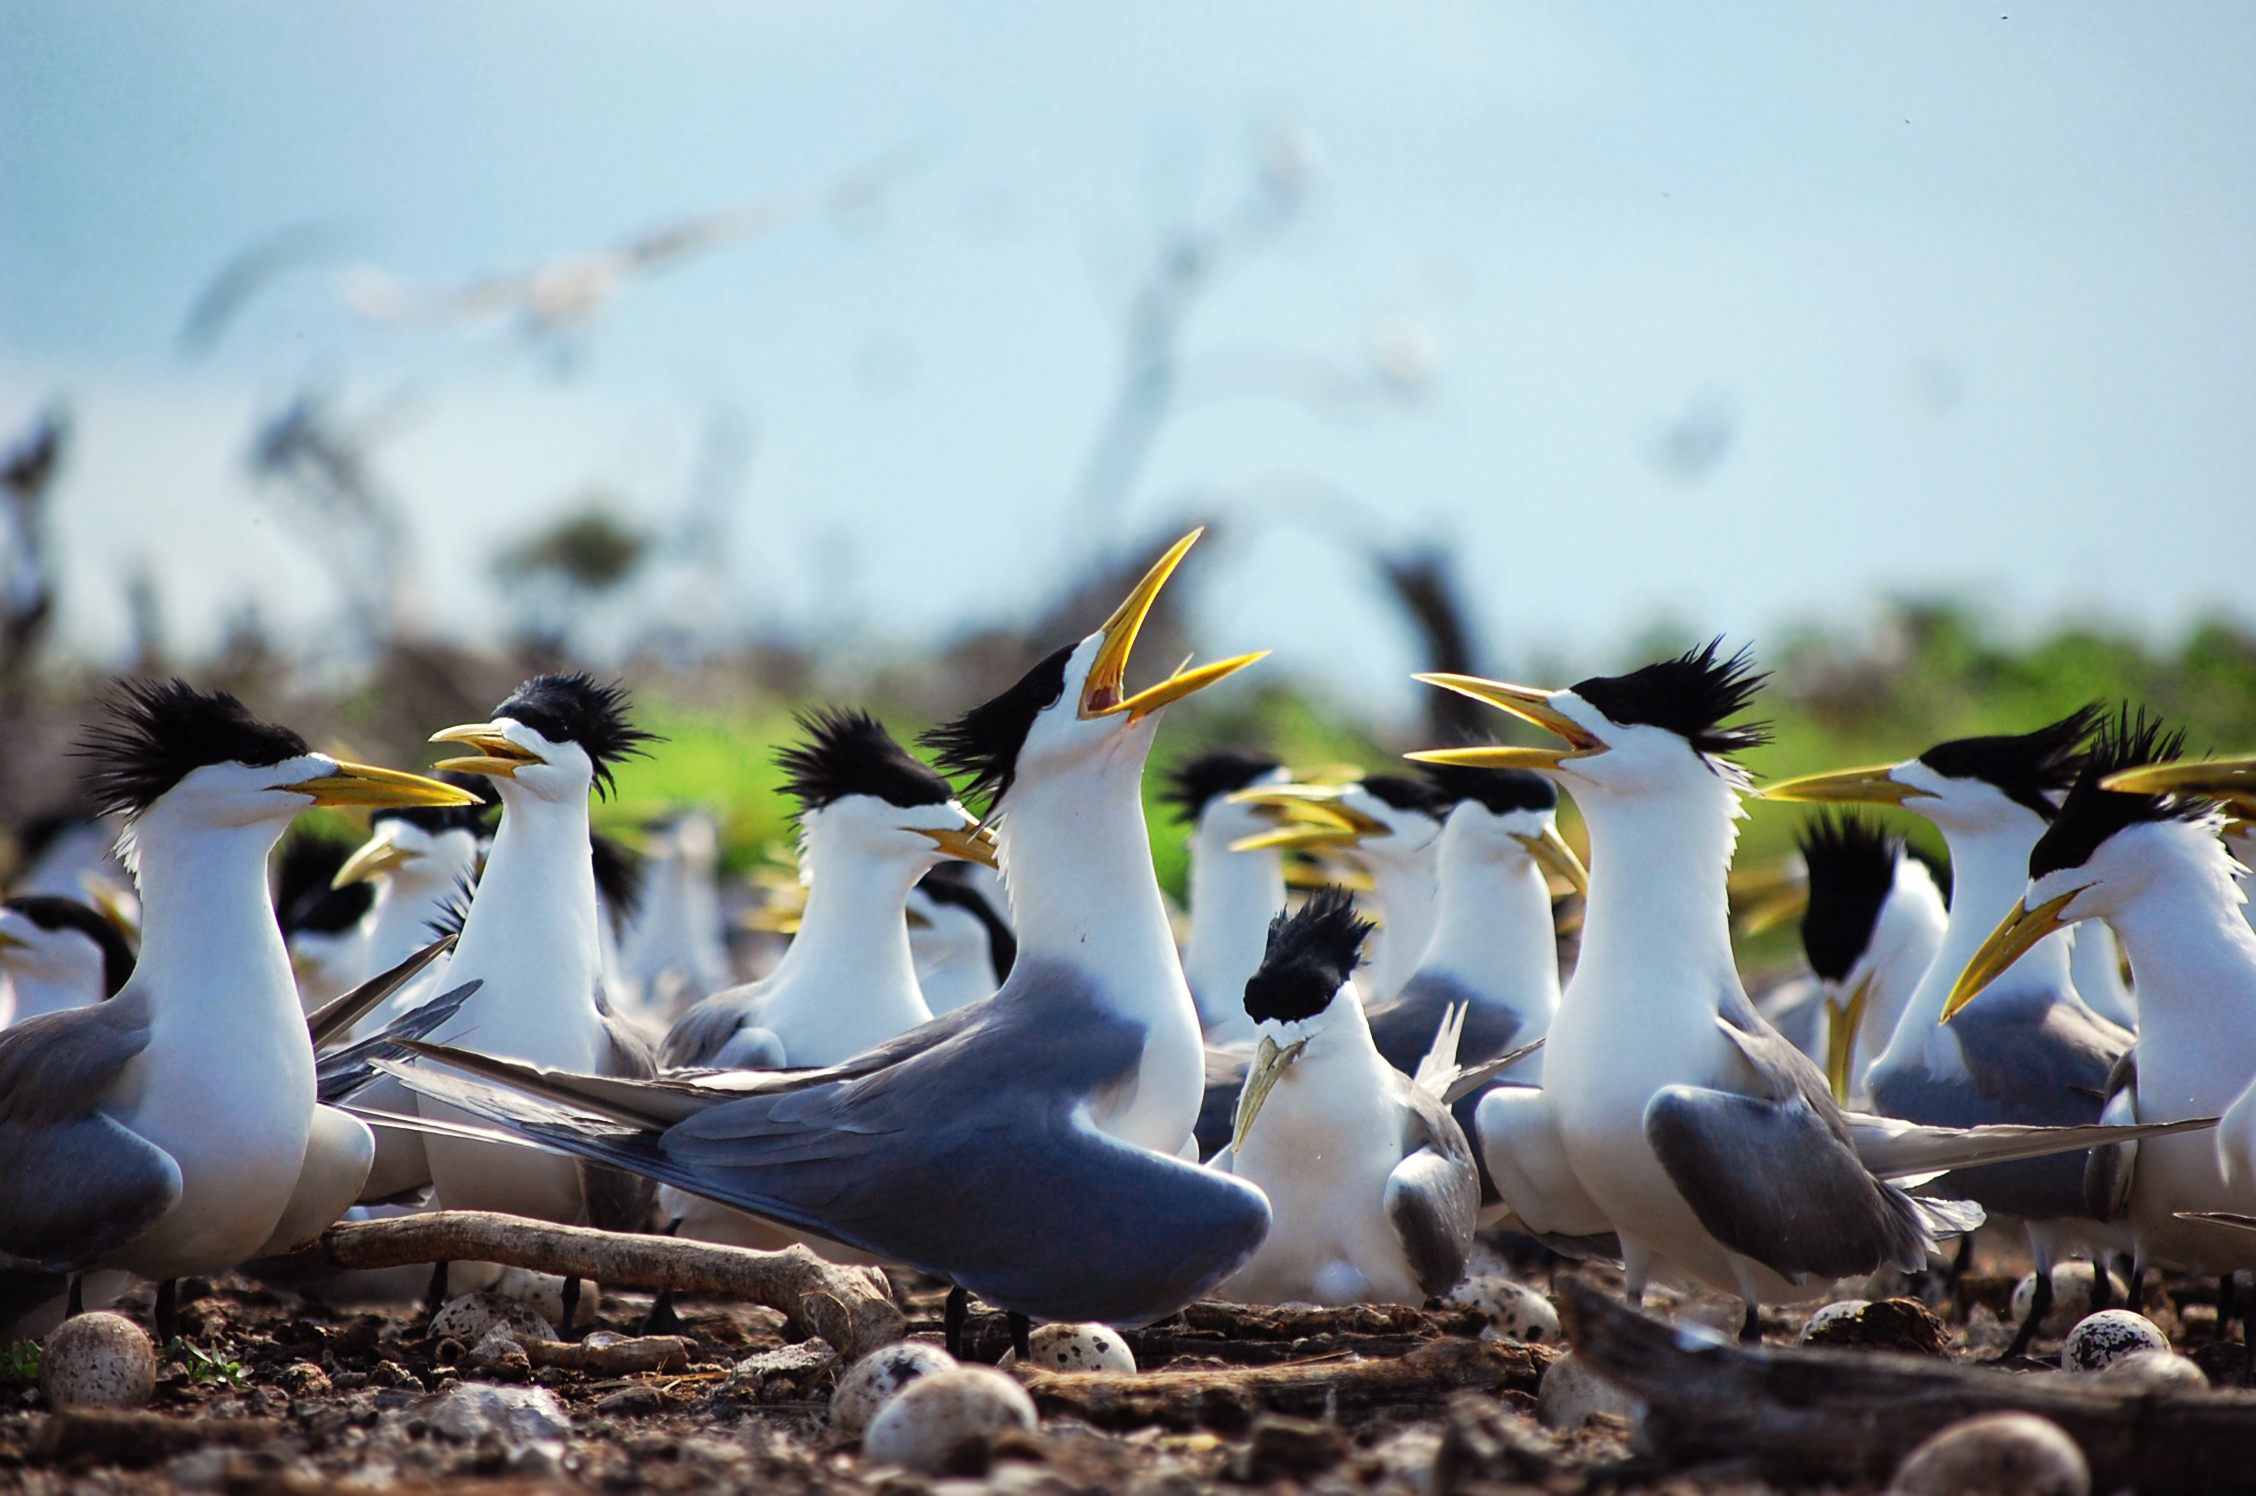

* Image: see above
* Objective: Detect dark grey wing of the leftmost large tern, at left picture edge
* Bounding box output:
[0,991,180,1273]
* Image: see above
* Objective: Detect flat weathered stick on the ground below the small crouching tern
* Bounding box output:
[1020,1340,1559,1433]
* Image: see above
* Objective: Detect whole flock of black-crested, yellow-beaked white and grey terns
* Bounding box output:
[0,533,2256,1389]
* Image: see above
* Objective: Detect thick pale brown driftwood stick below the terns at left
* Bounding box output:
[266,1209,905,1358]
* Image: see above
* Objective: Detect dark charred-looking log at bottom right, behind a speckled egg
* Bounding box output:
[1561,1284,2256,1494]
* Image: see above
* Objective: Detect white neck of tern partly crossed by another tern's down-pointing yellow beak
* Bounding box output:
[1879,806,2076,1065]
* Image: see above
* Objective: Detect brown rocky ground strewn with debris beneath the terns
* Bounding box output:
[0,1268,2240,1496]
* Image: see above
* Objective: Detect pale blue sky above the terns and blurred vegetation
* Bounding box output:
[0,0,2256,722]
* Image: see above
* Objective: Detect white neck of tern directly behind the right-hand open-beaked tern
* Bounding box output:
[1417,806,1559,1024]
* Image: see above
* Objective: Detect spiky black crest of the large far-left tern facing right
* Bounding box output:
[77,679,314,817]
